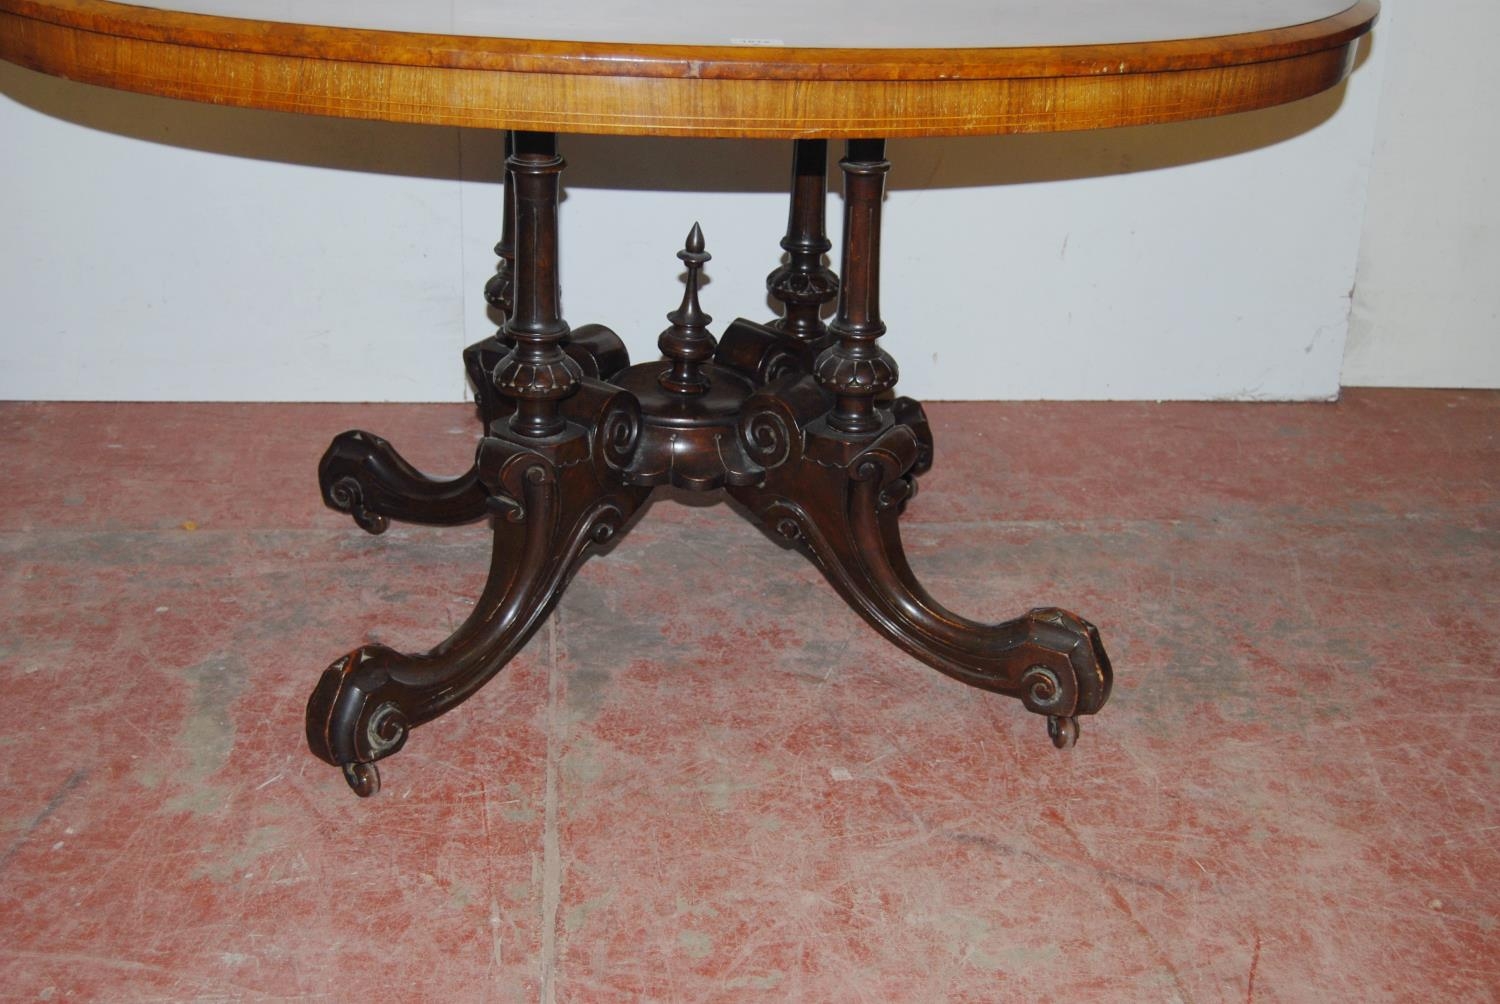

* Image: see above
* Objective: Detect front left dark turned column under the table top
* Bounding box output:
[495,132,584,438]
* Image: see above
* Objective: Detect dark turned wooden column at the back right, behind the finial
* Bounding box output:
[765,140,839,342]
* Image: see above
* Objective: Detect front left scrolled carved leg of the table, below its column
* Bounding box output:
[308,381,647,795]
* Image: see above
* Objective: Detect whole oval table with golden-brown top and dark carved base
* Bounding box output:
[0,0,1379,795]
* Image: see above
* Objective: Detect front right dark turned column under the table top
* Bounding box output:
[813,140,897,435]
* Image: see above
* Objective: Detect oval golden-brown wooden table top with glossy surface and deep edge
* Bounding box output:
[0,0,1379,138]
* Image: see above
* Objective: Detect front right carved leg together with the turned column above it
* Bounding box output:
[729,140,1112,746]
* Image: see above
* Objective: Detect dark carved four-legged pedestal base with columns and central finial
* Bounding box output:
[308,134,1112,795]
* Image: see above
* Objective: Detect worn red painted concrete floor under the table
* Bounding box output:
[0,392,1500,1004]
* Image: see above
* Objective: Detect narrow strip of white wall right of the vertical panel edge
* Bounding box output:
[1344,0,1500,387]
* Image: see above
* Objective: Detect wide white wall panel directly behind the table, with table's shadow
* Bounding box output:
[0,41,1383,401]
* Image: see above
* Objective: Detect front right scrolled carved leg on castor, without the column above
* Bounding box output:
[729,378,1112,746]
